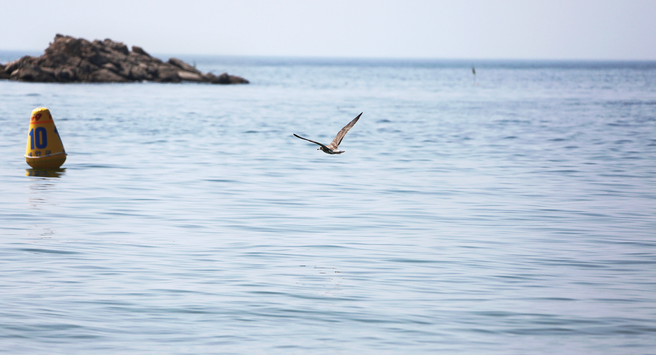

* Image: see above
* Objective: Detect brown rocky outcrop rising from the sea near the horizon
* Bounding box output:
[0,34,248,84]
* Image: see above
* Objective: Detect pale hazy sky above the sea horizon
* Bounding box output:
[0,0,656,60]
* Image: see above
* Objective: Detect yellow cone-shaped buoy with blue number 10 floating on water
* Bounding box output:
[25,107,66,169]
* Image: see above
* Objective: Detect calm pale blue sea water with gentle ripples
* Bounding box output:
[0,57,656,354]
